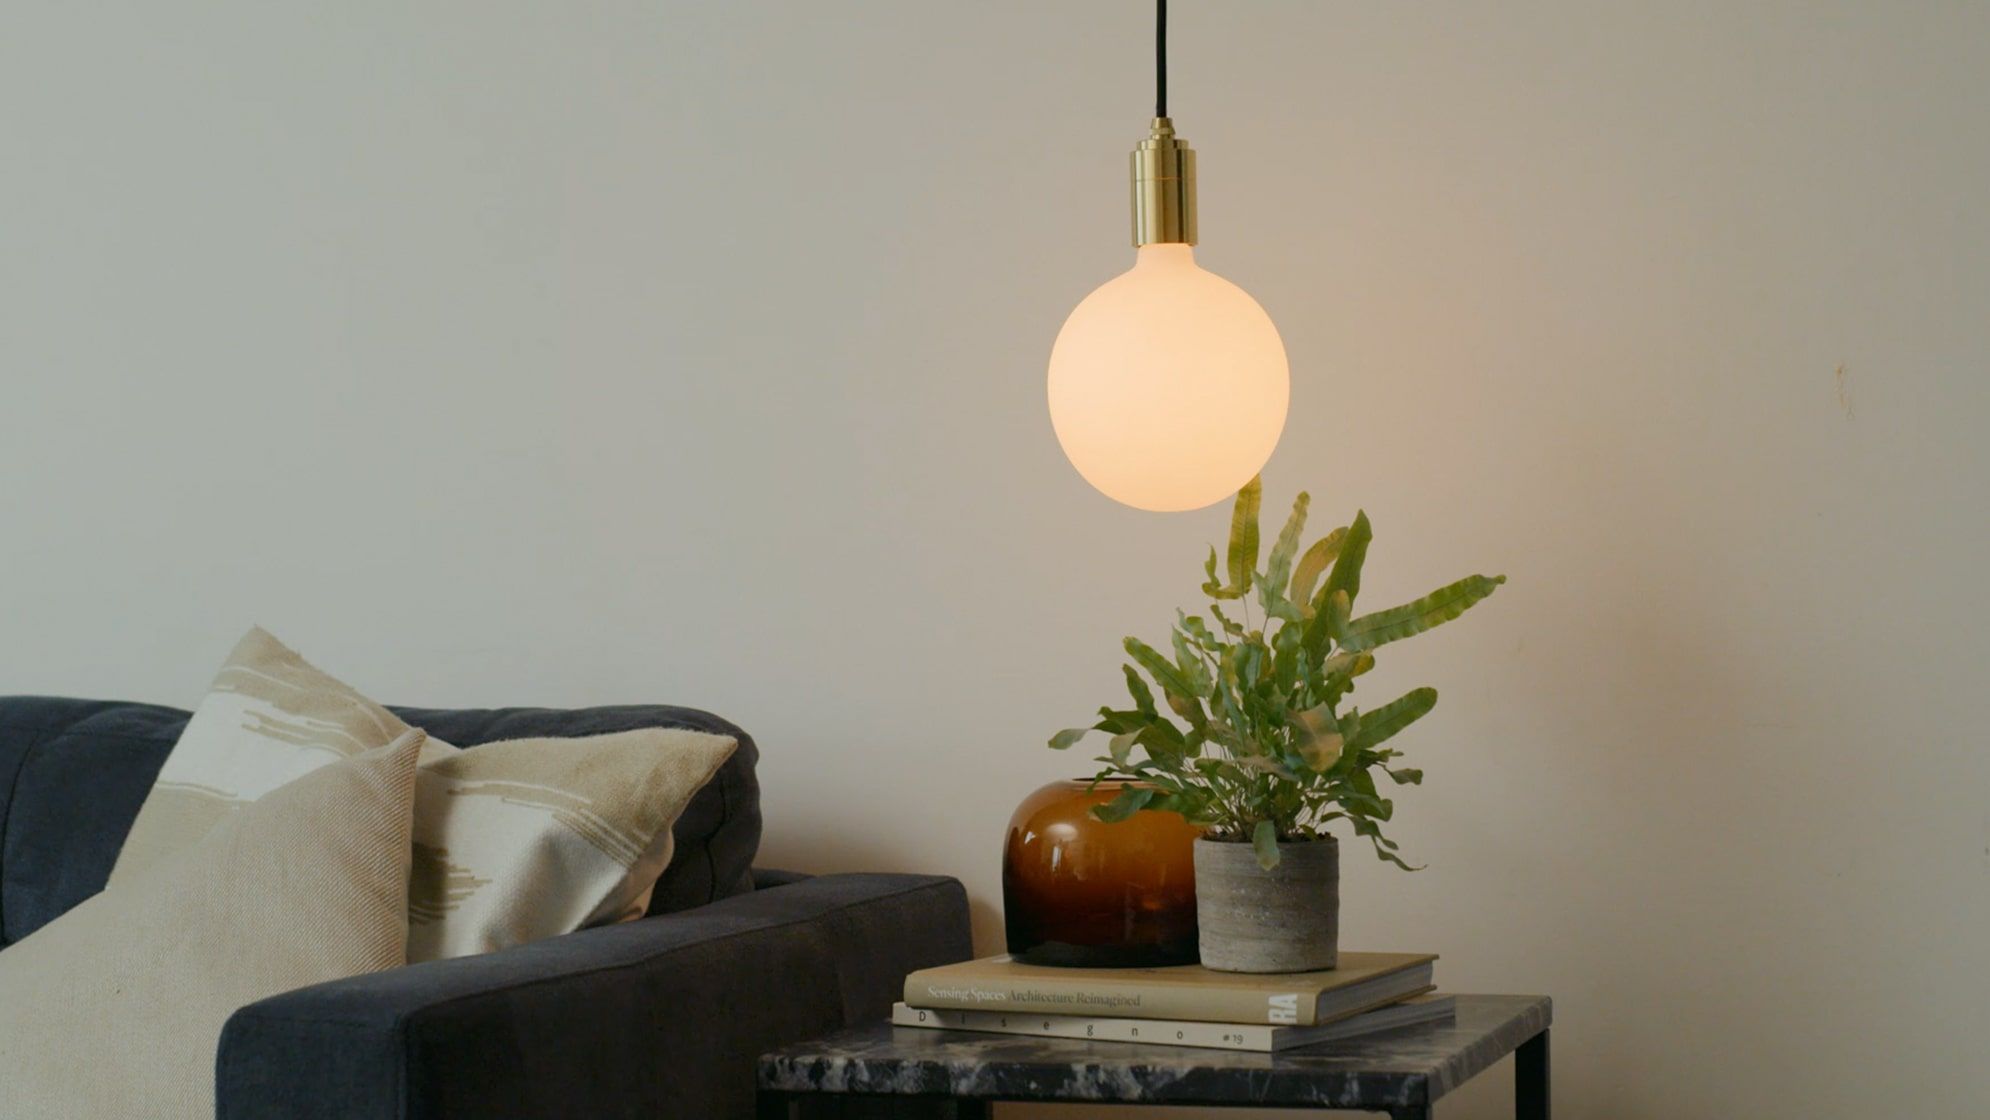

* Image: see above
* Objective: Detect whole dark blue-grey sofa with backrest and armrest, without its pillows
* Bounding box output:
[0,696,969,1120]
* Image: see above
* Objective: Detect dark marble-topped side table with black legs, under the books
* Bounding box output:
[760,995,1554,1120]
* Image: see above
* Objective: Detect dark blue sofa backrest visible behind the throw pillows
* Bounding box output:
[0,696,760,947]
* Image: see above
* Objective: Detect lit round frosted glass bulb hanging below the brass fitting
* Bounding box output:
[1051,243,1292,511]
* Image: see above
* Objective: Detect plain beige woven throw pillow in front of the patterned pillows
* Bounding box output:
[0,730,422,1120]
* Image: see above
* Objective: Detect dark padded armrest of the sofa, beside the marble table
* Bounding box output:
[215,875,969,1120]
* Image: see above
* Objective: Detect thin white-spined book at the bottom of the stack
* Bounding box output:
[892,995,1457,1052]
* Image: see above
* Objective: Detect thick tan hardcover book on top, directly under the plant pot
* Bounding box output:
[905,953,1437,1027]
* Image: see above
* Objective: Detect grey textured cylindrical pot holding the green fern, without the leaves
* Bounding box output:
[1196,836,1341,973]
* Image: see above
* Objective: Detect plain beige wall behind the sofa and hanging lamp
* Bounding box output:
[0,0,1990,1120]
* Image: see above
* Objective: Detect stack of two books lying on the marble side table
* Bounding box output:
[892,953,1455,1052]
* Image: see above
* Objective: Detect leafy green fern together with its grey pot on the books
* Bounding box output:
[1051,479,1506,973]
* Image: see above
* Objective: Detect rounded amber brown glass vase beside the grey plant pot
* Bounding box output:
[1001,780,1200,969]
